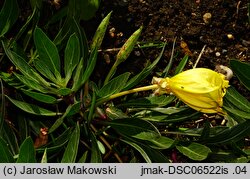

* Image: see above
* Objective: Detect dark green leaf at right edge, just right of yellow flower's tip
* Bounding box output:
[229,60,250,90]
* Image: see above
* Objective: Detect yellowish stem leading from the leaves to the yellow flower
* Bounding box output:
[96,84,159,106]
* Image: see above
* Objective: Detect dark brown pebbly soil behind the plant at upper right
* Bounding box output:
[83,0,250,99]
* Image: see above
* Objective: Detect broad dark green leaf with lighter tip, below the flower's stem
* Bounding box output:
[105,118,160,141]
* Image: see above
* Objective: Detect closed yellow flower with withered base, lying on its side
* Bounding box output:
[152,68,229,114]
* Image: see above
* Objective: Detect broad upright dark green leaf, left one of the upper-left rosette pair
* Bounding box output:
[34,27,61,83]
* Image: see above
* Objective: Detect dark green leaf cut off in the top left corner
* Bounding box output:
[0,0,20,37]
